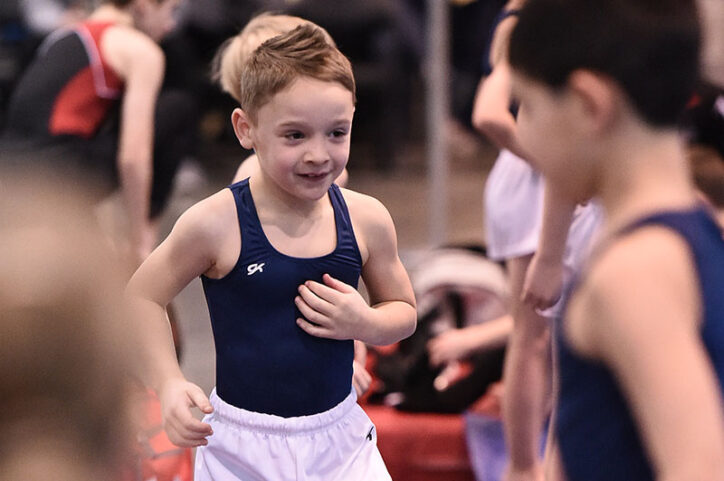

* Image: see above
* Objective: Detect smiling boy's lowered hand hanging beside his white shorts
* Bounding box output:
[159,379,214,448]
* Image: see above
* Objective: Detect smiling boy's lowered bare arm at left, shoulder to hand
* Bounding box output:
[126,192,233,447]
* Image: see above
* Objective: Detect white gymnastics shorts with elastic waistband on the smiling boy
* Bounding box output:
[194,389,391,481]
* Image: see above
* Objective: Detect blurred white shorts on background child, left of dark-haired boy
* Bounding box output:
[483,150,543,261]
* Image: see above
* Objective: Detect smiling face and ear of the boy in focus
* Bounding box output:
[235,77,354,200]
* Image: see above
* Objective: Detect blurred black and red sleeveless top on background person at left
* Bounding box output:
[7,21,123,141]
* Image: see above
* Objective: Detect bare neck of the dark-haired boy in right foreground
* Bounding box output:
[599,129,696,231]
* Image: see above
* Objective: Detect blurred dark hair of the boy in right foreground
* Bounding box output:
[509,0,700,127]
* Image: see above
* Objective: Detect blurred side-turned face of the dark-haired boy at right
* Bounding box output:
[513,71,594,202]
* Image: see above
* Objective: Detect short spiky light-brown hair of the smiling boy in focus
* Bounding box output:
[240,25,356,121]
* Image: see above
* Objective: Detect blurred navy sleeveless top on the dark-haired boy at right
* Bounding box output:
[556,208,724,481]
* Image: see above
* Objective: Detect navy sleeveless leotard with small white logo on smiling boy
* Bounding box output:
[201,179,362,417]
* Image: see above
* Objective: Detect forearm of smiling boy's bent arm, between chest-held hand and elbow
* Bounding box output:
[358,301,417,346]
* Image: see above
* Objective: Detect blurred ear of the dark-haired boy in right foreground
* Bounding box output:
[568,70,620,132]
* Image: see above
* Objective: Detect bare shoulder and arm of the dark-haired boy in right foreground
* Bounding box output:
[567,228,724,481]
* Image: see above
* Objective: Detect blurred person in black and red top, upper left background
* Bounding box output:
[0,0,192,263]
